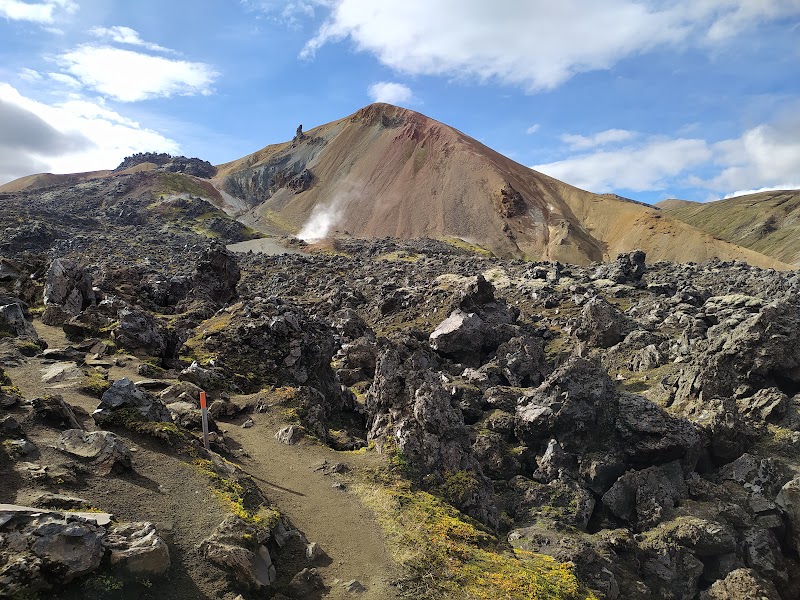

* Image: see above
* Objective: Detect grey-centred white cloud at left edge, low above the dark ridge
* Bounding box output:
[0,83,180,184]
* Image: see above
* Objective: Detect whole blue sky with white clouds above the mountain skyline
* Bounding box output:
[0,0,800,202]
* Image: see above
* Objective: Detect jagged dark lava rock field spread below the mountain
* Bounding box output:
[0,174,800,600]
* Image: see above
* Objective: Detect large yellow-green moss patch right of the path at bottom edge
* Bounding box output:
[352,470,594,600]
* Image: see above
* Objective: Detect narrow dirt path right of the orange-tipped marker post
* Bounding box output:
[225,406,397,600]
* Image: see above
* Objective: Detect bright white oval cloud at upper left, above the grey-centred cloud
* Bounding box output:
[59,45,219,102]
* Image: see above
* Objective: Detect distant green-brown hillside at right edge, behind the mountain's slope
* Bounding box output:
[657,190,800,265]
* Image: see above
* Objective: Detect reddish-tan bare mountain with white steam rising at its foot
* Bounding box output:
[0,103,787,269]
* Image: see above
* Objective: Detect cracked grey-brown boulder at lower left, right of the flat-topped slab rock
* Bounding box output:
[103,522,170,577]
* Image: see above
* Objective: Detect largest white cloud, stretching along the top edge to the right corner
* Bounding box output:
[301,0,800,91]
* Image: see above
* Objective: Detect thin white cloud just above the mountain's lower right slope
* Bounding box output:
[531,138,713,193]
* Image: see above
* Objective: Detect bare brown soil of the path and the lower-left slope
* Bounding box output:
[0,321,397,600]
